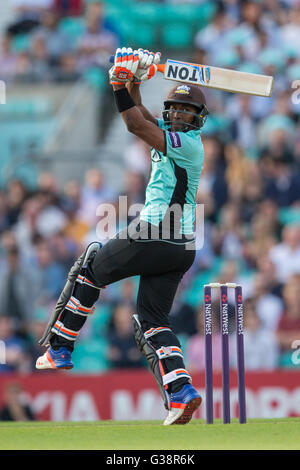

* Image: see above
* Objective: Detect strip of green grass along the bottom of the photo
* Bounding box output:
[0,418,300,450]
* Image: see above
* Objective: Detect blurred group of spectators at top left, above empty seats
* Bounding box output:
[0,0,120,83]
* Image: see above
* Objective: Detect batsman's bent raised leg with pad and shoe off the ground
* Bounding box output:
[36,229,182,369]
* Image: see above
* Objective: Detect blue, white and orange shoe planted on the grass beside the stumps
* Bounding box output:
[164,384,202,426]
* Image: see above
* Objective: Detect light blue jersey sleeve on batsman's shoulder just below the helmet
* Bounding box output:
[165,131,204,166]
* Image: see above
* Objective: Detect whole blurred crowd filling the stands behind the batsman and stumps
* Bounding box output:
[0,0,300,373]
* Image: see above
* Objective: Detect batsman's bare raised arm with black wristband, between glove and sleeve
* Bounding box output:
[113,81,166,154]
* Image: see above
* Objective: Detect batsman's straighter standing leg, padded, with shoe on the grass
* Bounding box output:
[134,272,202,425]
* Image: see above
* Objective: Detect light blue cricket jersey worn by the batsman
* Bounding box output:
[140,119,204,238]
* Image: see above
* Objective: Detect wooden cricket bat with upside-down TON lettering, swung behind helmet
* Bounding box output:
[110,56,274,97]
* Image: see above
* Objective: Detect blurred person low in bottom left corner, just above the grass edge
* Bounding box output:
[0,382,35,421]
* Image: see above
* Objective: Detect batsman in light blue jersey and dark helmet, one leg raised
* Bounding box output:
[36,48,208,425]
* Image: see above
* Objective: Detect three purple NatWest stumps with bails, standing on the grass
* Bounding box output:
[204,283,246,424]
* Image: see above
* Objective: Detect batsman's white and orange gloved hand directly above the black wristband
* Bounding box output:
[108,47,139,85]
